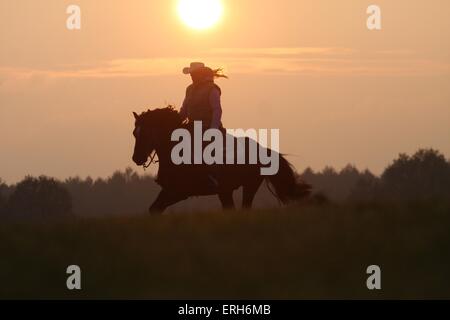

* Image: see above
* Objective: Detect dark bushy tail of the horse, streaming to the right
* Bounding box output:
[266,154,311,204]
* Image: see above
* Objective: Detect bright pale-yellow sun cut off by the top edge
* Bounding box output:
[178,0,223,30]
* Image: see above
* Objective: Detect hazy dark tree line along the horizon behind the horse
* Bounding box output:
[0,149,450,219]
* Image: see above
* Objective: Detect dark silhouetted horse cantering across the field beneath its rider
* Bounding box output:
[133,107,310,213]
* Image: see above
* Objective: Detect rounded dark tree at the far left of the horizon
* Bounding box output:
[8,176,72,219]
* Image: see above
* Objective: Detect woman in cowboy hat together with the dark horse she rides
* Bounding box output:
[133,62,310,213]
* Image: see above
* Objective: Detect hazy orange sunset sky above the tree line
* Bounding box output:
[0,0,450,183]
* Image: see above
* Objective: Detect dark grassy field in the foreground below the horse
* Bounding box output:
[0,205,450,299]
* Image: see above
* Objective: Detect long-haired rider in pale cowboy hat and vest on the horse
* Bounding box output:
[180,62,228,129]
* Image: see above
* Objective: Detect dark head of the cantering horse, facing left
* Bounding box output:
[133,107,181,166]
